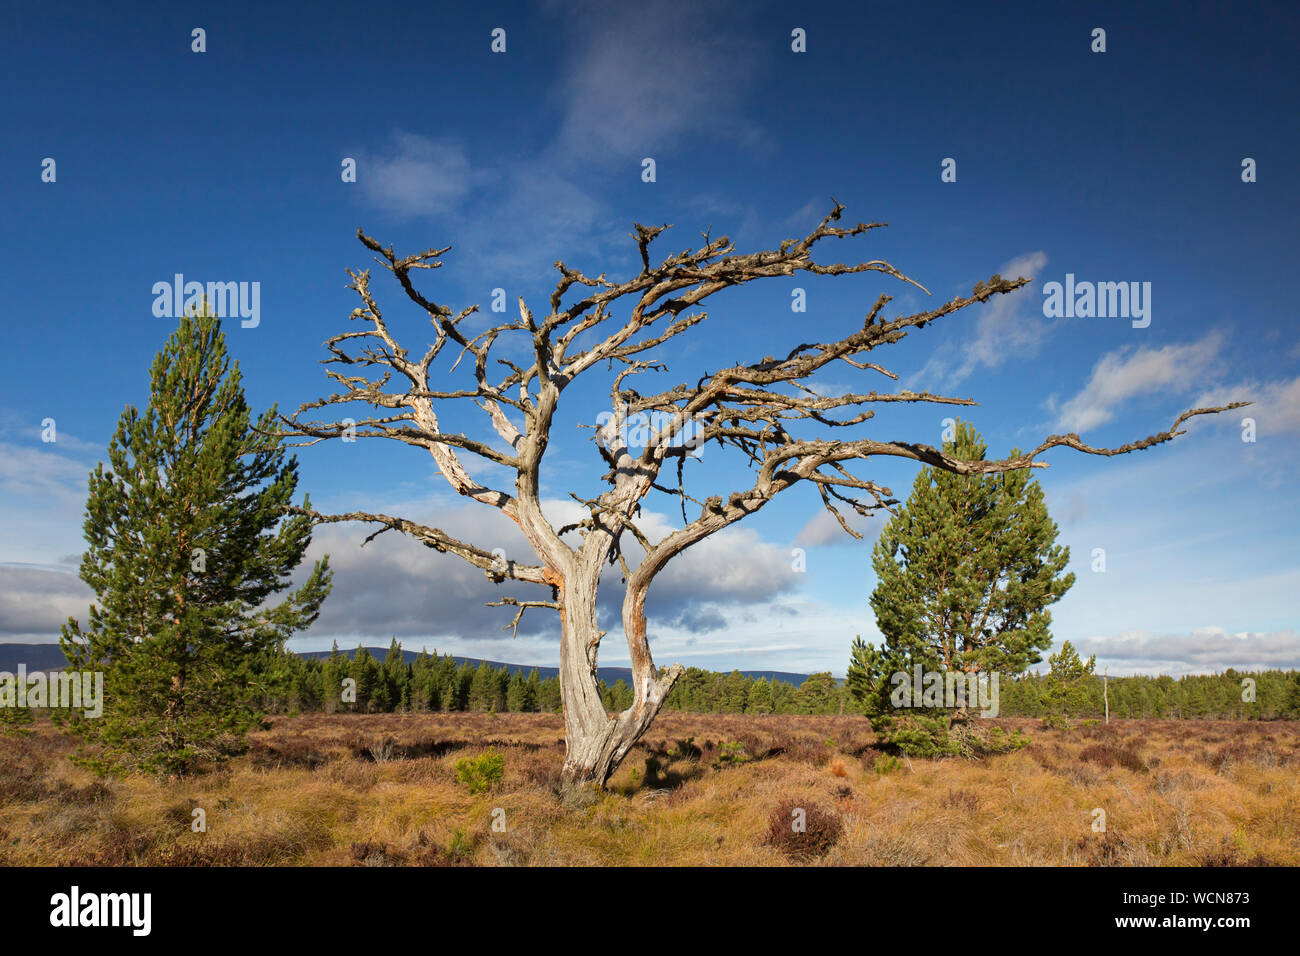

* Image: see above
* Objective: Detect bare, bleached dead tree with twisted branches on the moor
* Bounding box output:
[283,203,1235,784]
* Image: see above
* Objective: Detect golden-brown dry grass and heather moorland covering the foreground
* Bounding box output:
[0,713,1300,866]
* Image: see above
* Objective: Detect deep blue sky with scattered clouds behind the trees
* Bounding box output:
[0,3,1300,674]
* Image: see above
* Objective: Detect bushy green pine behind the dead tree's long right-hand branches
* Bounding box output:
[848,421,1074,749]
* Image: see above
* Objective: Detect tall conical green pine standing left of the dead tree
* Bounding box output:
[61,308,330,773]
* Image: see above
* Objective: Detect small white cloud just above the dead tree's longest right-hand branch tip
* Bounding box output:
[1056,332,1223,432]
